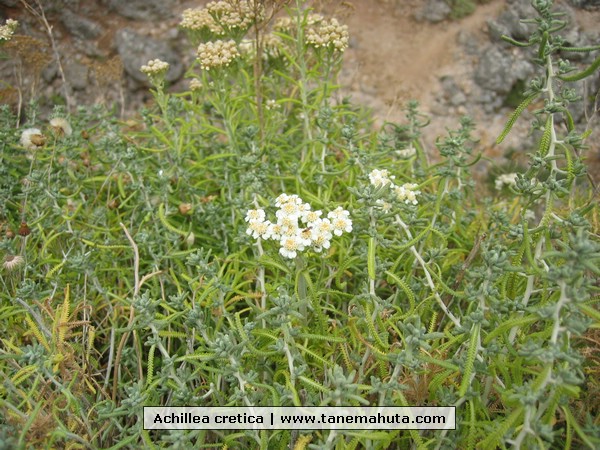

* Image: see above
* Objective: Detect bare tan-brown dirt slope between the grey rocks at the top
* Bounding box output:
[336,0,506,120]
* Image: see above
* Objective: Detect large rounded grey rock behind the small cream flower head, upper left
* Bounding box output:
[115,28,184,86]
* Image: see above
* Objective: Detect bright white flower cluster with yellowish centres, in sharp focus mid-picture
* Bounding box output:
[245,194,352,259]
